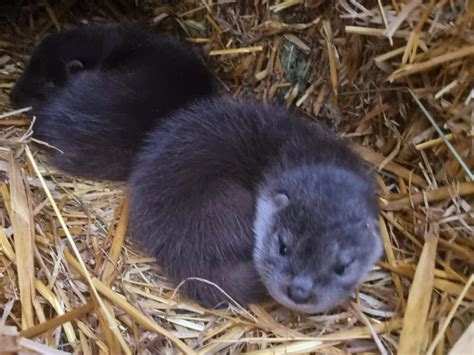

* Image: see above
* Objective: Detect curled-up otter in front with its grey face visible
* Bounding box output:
[129,98,382,312]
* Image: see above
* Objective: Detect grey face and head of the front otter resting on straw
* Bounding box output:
[253,165,382,313]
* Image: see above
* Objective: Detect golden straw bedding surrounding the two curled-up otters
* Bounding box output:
[0,0,474,354]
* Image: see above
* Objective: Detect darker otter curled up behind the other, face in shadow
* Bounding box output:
[11,24,217,180]
